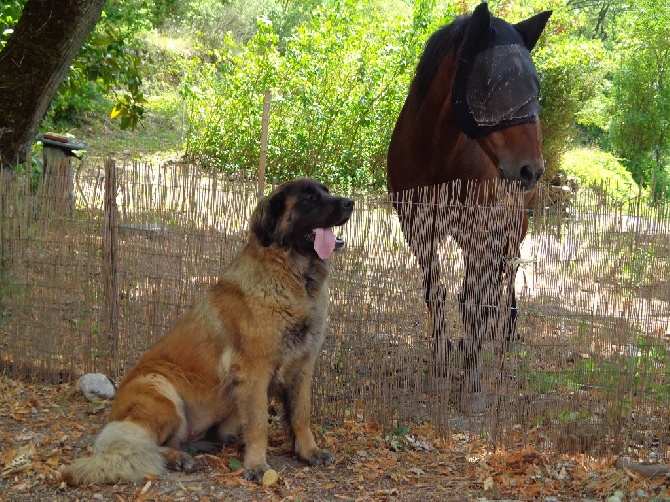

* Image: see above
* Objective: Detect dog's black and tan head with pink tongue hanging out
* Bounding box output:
[250,178,354,260]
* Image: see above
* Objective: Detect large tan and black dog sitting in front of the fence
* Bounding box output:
[62,178,354,484]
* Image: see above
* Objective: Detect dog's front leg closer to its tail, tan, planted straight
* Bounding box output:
[236,372,270,481]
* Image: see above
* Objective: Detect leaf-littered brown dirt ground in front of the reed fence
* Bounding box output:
[0,377,670,502]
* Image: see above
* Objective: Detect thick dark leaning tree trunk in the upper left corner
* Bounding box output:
[0,0,105,168]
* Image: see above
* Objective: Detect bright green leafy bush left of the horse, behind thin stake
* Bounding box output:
[184,0,452,190]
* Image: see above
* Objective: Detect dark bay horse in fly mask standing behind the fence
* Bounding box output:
[387,3,551,411]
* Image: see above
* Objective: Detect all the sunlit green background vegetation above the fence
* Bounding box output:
[0,0,670,203]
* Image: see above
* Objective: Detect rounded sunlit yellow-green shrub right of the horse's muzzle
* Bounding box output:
[561,148,646,206]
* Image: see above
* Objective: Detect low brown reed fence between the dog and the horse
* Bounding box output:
[0,162,670,460]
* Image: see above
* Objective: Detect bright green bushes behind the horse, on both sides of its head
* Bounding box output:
[181,0,624,189]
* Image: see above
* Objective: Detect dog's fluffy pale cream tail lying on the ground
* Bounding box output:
[61,422,166,485]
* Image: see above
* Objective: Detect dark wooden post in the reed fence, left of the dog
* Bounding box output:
[102,158,120,382]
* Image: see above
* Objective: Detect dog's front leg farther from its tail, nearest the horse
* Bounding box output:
[284,363,335,465]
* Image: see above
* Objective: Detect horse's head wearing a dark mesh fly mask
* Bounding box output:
[451,3,551,189]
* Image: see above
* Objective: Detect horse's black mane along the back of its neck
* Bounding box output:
[414,14,472,103]
